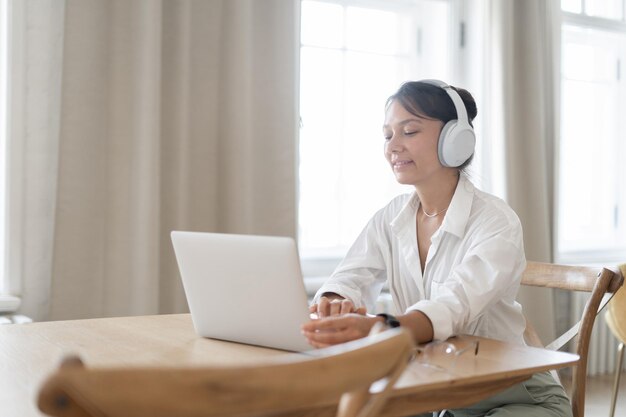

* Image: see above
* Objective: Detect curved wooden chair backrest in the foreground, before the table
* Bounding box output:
[38,329,413,417]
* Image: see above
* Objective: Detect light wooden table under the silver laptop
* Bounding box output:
[0,314,578,417]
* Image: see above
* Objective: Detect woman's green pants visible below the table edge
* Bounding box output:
[416,372,572,417]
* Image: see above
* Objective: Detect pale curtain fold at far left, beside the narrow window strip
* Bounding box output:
[7,0,65,317]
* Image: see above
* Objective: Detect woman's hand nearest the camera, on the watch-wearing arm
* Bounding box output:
[302,313,380,348]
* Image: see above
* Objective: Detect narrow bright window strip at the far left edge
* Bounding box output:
[0,0,9,294]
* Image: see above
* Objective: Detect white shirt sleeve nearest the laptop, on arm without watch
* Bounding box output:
[313,211,389,311]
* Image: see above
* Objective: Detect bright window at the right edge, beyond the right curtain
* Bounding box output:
[557,0,626,262]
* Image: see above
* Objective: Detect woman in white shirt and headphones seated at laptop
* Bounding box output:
[302,80,571,416]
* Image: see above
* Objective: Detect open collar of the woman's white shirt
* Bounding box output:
[390,174,474,238]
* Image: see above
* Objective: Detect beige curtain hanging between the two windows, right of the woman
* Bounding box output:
[488,0,561,342]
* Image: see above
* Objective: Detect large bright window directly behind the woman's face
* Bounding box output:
[299,0,454,275]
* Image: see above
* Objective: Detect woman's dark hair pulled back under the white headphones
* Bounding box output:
[385,81,478,171]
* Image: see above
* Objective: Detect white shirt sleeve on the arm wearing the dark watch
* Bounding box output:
[407,219,526,340]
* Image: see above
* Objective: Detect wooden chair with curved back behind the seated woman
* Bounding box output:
[522,262,624,417]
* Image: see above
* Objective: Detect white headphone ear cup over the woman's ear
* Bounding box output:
[437,120,476,168]
